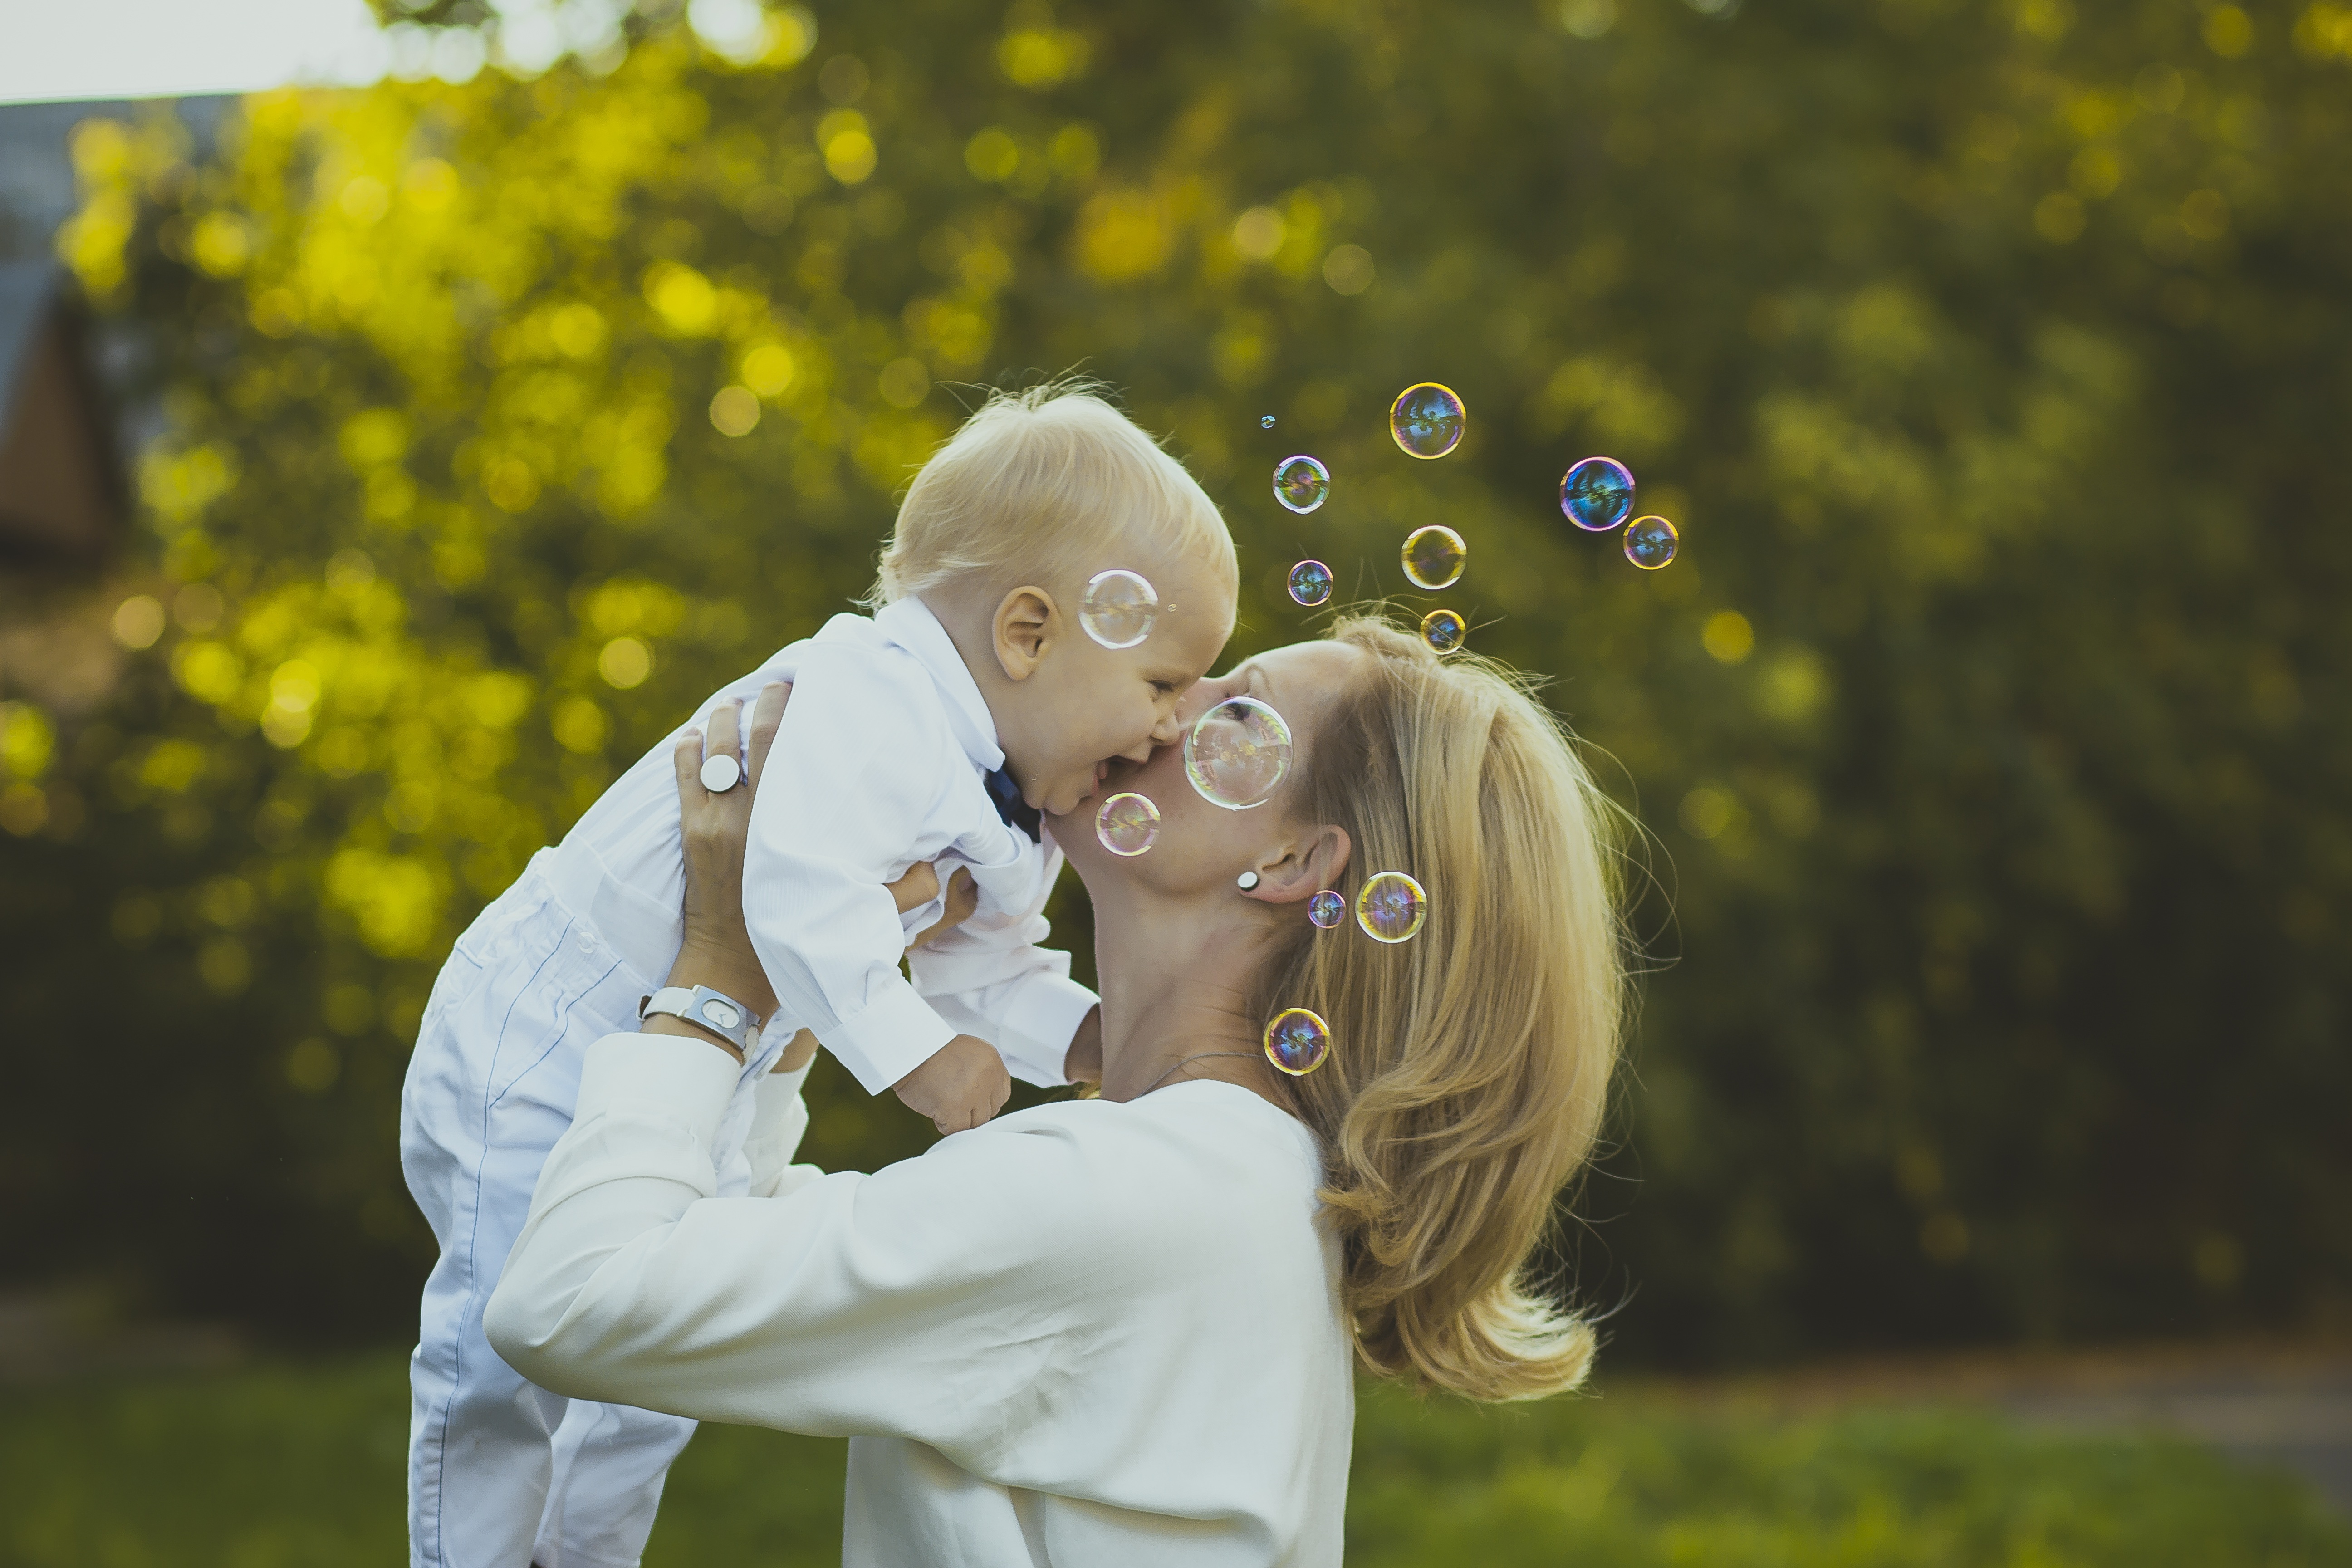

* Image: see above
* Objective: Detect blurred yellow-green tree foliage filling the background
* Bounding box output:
[0,0,2352,1361]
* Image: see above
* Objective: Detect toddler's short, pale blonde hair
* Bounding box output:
[866,378,1240,609]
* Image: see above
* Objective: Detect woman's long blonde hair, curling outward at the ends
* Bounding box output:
[1254,616,1625,1399]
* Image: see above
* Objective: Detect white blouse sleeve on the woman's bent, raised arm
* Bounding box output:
[485,1034,1124,1467]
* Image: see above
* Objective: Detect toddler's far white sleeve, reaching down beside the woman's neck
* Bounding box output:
[906,848,1096,1086]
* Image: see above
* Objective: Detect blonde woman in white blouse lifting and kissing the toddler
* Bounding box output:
[489,621,1621,1566]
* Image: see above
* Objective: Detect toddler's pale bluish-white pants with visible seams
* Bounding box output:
[400,848,790,1568]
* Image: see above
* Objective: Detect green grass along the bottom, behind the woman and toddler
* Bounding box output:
[0,1357,2352,1568]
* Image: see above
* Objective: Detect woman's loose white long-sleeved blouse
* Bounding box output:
[487,1034,1355,1568]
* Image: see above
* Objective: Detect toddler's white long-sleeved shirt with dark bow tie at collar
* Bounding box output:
[558,597,1096,1093]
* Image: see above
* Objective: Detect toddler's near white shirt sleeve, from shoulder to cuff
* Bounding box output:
[743,647,960,1093]
